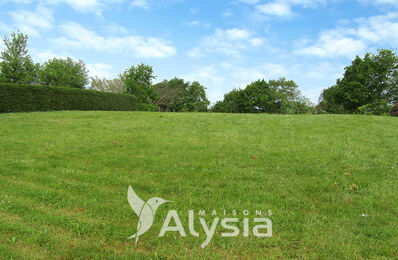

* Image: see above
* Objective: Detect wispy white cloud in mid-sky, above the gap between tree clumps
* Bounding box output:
[188,28,263,58]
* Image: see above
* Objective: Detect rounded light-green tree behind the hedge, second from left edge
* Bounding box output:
[39,57,89,88]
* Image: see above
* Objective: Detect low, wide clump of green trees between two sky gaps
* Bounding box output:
[212,78,312,114]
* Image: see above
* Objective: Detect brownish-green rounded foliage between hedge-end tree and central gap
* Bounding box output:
[155,78,210,112]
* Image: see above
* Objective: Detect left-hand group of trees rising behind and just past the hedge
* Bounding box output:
[0,32,210,112]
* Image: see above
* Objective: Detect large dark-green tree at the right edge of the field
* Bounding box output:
[320,49,398,113]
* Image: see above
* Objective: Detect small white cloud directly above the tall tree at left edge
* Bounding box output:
[10,7,54,36]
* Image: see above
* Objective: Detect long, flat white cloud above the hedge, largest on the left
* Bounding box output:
[54,23,176,58]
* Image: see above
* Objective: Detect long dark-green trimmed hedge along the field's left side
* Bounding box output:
[0,82,137,113]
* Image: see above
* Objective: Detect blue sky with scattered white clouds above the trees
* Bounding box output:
[0,0,398,103]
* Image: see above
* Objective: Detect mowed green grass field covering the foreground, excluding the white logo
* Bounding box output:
[0,112,398,259]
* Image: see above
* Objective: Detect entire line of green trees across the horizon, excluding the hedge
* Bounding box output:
[0,32,398,114]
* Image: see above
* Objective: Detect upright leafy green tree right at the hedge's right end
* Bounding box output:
[122,63,158,110]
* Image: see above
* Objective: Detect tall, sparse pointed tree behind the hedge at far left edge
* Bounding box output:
[0,32,38,84]
